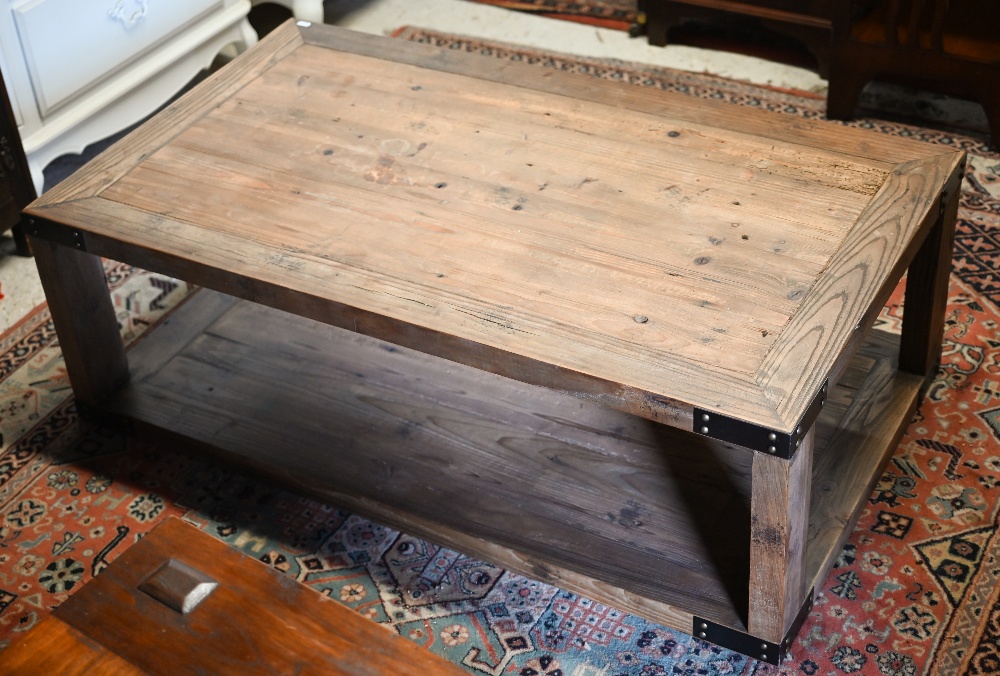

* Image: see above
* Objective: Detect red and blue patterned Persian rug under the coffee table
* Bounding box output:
[0,29,1000,676]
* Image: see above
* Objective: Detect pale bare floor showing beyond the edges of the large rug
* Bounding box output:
[0,0,876,331]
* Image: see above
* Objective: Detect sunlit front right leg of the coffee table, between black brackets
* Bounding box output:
[747,428,816,643]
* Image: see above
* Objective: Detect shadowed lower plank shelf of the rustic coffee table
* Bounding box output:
[109,290,921,632]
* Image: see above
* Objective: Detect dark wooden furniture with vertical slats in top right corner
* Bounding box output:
[827,0,1000,146]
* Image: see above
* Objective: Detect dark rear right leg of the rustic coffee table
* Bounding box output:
[899,177,961,378]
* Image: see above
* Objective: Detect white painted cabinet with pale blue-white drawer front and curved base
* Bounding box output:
[0,0,257,192]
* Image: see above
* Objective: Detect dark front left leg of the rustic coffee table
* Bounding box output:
[31,237,128,405]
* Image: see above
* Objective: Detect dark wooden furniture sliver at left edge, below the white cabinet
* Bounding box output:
[0,74,36,256]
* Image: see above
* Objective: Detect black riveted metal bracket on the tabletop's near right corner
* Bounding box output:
[694,381,829,460]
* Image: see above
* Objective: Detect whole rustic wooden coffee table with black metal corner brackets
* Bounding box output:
[26,23,964,662]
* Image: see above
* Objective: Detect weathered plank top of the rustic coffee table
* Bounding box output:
[27,22,963,431]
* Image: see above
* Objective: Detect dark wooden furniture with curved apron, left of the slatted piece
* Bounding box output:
[640,0,836,77]
